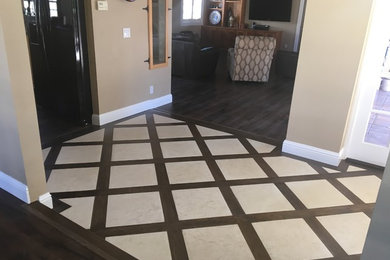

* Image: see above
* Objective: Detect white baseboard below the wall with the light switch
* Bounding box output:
[92,94,172,125]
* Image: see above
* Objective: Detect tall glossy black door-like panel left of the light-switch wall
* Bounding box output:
[22,0,92,147]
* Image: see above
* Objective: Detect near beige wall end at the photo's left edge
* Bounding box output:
[0,0,46,201]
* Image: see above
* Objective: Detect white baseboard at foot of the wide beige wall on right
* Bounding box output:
[282,140,341,166]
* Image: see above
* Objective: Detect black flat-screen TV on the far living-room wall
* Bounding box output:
[249,0,292,22]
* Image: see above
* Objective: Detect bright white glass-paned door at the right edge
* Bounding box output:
[347,0,390,166]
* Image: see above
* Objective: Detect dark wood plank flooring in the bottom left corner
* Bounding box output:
[0,189,103,259]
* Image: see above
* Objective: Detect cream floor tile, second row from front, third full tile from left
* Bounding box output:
[231,183,294,214]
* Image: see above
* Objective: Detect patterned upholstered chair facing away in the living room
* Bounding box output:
[227,35,276,82]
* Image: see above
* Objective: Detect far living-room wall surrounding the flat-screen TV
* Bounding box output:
[245,0,302,51]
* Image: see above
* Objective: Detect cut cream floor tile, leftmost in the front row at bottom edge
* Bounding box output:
[106,232,172,260]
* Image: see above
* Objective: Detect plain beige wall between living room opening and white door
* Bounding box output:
[287,0,373,153]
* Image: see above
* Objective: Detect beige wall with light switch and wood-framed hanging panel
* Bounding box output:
[86,0,172,114]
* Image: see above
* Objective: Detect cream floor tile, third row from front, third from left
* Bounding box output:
[165,161,214,184]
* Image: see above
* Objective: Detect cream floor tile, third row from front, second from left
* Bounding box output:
[110,164,157,188]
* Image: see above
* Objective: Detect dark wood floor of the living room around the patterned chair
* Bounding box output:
[158,52,294,142]
